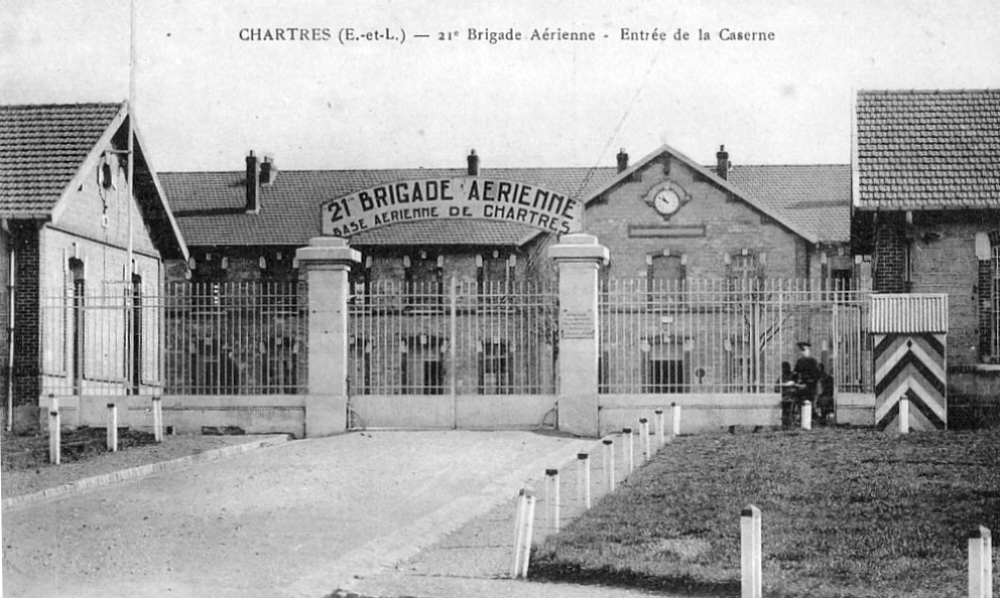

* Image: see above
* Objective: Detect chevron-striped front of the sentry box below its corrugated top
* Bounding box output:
[873,332,948,430]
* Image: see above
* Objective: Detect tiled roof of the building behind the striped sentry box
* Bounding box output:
[854,89,1000,210]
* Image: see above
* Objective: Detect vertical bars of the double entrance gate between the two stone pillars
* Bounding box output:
[348,280,557,395]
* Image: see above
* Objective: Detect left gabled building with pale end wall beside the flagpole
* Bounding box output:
[0,103,187,432]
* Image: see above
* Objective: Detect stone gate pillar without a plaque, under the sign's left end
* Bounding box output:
[295,237,361,437]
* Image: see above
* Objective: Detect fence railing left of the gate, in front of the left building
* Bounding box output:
[40,283,308,395]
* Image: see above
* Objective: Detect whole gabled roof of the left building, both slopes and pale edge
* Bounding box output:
[0,102,187,257]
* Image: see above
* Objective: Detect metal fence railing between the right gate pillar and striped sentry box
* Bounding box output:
[599,278,871,394]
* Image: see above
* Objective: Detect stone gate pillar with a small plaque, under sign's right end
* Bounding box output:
[549,233,608,437]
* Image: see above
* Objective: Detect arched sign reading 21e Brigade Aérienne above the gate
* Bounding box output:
[321,177,583,237]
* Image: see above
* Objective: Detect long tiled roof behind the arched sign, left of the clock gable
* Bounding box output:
[159,168,615,246]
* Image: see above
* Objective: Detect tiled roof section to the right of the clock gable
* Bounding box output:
[729,164,851,243]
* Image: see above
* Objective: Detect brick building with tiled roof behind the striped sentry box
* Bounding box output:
[852,90,1000,420]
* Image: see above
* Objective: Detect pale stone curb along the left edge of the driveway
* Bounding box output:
[0,436,288,509]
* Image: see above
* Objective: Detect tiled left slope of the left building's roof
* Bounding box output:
[0,104,123,218]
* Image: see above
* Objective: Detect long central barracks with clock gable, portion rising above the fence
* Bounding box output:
[161,146,857,290]
